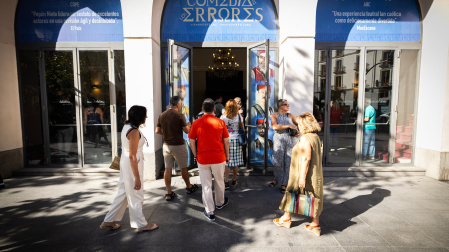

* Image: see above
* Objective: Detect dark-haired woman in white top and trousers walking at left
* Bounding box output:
[100,106,158,232]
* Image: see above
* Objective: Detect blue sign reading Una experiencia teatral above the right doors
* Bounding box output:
[315,0,421,42]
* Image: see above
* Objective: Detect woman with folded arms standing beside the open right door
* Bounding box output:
[269,99,299,194]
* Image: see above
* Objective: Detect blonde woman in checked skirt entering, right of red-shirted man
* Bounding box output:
[220,99,245,190]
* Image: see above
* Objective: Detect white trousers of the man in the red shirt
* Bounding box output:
[198,162,226,215]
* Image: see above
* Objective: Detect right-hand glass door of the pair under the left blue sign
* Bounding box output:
[78,50,114,164]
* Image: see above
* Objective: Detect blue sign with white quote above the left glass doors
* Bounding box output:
[16,0,124,42]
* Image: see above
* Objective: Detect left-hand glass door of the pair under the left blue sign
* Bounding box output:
[40,50,81,165]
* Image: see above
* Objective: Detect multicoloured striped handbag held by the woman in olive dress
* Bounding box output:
[284,188,320,217]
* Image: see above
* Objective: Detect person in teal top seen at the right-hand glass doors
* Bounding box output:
[362,98,376,160]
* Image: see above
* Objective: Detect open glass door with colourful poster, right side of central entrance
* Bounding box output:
[246,39,275,171]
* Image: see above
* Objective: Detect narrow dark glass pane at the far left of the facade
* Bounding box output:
[19,51,45,165]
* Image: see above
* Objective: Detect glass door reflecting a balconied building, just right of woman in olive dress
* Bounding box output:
[322,49,360,165]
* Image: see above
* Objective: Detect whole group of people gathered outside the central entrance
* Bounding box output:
[100,96,323,235]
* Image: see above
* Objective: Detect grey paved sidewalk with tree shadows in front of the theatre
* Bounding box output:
[0,176,449,252]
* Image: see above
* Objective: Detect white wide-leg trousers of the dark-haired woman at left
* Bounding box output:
[104,155,148,228]
